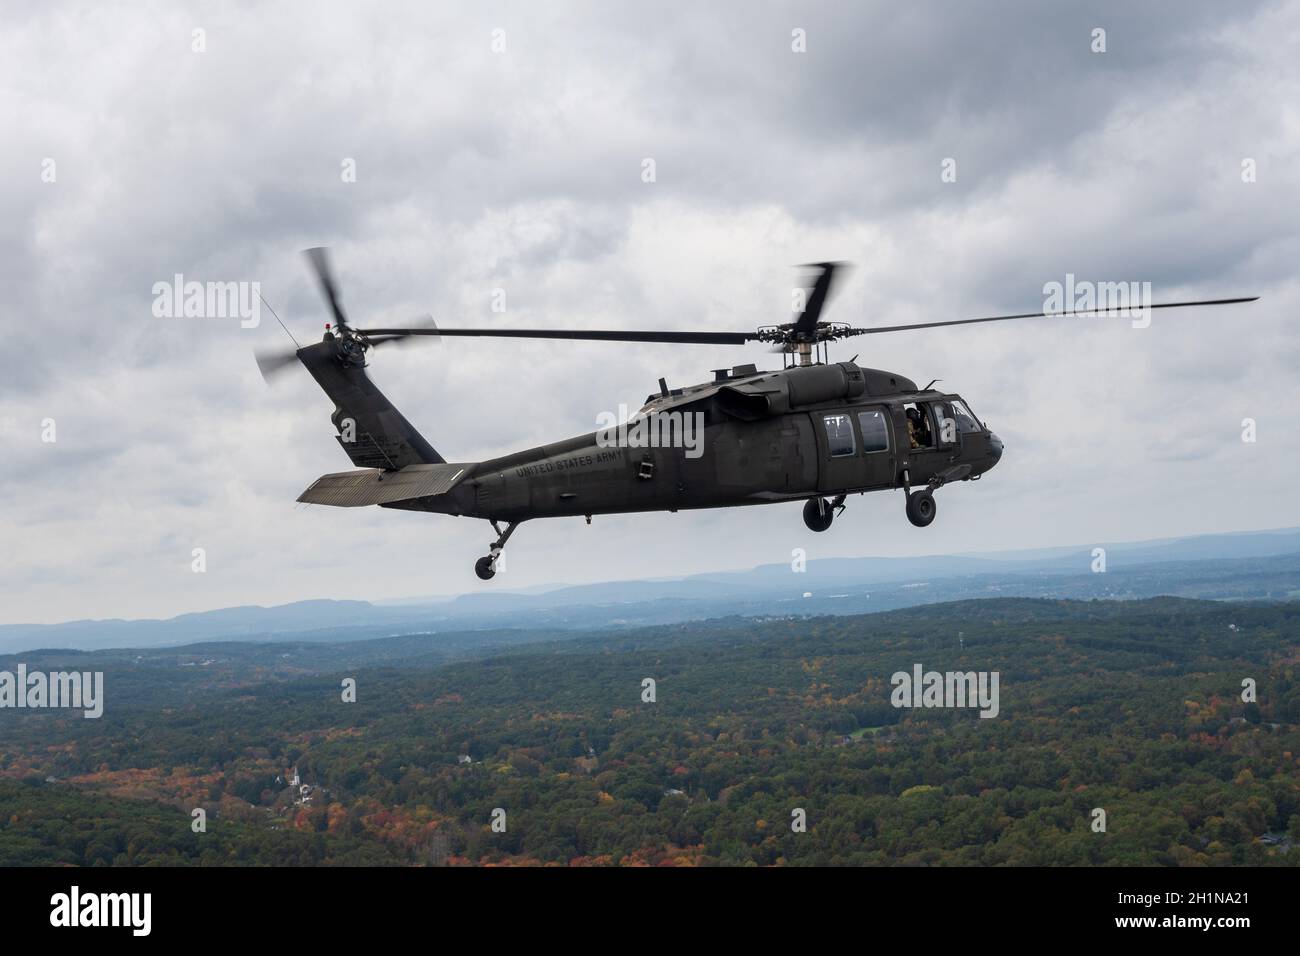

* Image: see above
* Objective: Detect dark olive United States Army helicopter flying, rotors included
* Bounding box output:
[257,248,1257,580]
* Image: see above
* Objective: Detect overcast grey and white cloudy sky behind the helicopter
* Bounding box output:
[0,0,1300,623]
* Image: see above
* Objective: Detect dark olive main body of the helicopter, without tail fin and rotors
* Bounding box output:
[386,362,1002,522]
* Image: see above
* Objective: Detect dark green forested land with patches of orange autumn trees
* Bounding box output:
[0,598,1300,865]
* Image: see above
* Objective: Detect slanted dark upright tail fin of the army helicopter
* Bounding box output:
[298,338,446,471]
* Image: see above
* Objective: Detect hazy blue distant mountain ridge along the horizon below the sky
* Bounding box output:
[0,528,1300,653]
